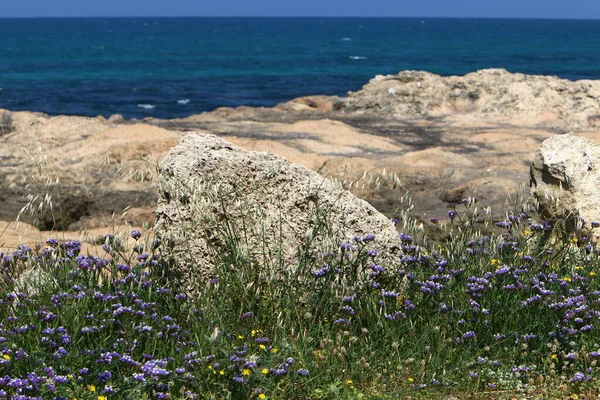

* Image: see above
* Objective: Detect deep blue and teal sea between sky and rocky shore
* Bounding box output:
[0,18,600,118]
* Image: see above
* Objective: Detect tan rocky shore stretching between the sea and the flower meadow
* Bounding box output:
[0,69,600,248]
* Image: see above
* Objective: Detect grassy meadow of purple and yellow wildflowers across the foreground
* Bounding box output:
[0,202,600,400]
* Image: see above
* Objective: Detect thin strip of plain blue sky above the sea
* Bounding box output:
[0,0,600,19]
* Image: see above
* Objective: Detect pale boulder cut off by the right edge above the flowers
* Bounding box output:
[531,134,600,241]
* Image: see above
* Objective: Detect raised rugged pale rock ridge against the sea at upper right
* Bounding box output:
[336,69,600,132]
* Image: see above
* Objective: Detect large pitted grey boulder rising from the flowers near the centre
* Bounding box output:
[155,133,401,282]
